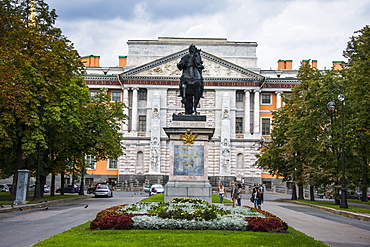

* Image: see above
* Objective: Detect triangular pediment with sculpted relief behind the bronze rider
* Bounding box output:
[120,49,264,80]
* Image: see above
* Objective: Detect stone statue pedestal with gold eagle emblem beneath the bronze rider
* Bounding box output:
[164,115,214,203]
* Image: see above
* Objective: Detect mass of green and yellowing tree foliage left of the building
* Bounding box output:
[0,0,125,200]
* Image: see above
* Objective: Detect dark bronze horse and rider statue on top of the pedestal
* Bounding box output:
[177,45,204,114]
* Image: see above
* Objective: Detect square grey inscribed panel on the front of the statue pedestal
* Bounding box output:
[173,145,204,176]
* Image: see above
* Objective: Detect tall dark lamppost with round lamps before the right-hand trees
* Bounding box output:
[327,89,348,208]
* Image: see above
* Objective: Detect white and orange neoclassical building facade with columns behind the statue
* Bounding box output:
[82,38,299,186]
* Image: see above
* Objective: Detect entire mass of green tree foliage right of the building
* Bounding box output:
[257,26,370,200]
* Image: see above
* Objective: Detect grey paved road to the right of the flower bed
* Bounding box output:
[243,193,370,247]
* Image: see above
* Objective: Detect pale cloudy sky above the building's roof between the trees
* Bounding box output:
[44,0,370,69]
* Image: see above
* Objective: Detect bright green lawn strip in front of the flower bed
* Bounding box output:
[34,222,327,247]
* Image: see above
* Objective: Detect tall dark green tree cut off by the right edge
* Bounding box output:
[343,25,370,201]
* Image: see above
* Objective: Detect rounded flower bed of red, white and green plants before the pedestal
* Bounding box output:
[90,198,288,232]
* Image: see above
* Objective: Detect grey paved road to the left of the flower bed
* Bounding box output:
[0,192,147,247]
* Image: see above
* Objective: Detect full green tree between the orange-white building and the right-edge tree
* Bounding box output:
[257,60,340,200]
